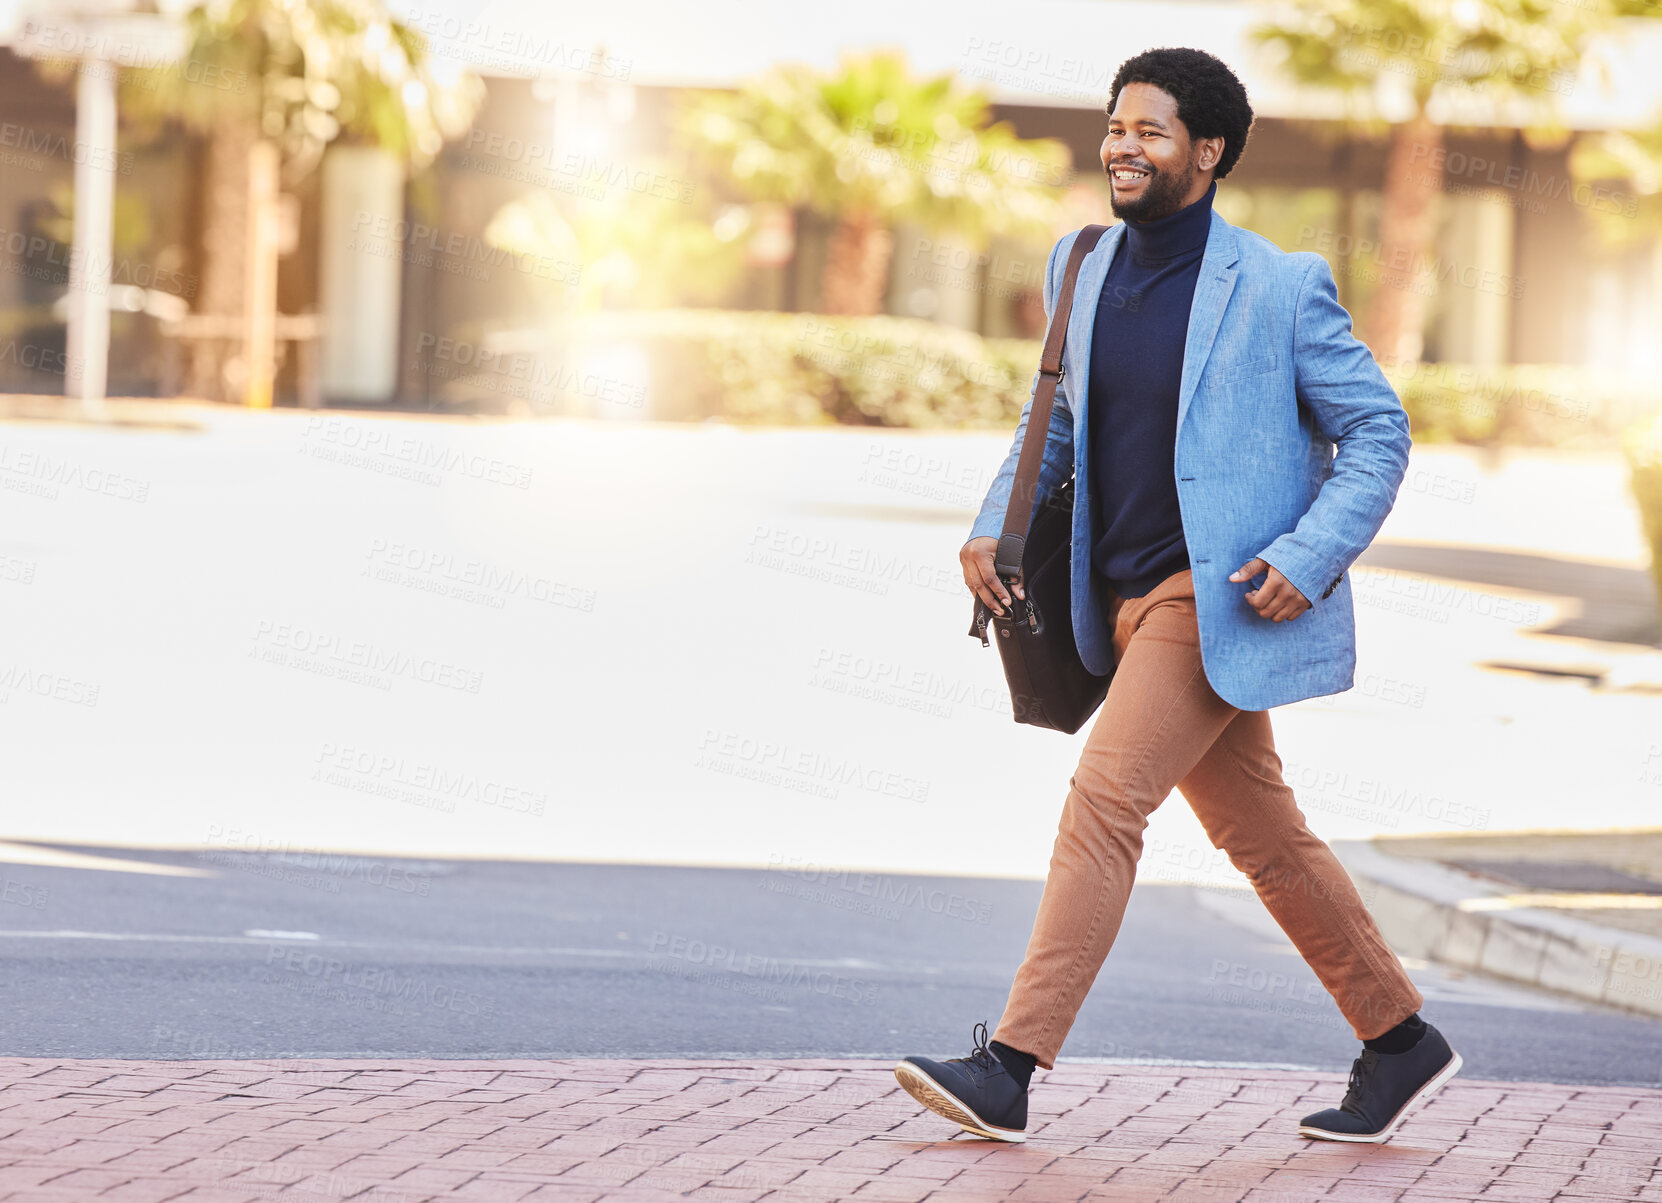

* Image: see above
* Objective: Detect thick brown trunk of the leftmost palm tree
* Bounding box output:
[186,116,259,400]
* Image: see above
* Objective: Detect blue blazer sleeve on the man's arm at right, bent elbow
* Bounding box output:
[1258,253,1411,606]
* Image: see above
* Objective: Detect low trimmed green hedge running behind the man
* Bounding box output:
[518,309,1655,447]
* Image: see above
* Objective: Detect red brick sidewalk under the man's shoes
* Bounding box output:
[0,1060,1662,1203]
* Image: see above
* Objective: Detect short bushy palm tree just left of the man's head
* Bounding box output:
[681,52,1070,314]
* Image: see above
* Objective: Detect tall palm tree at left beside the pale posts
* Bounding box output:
[123,0,484,397]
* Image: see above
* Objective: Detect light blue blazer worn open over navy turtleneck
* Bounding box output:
[971,211,1409,710]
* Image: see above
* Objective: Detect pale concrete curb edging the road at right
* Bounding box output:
[1333,839,1662,1017]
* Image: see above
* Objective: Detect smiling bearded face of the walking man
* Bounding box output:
[1102,83,1223,221]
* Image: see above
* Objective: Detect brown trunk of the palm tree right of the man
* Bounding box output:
[1366,111,1443,364]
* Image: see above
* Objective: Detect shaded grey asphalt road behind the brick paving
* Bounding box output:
[0,851,1662,1085]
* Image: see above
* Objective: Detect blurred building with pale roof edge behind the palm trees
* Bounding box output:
[0,0,1662,407]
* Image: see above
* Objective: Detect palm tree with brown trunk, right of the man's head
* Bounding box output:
[1251,0,1607,364]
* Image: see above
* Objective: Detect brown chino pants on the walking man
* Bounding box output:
[994,568,1424,1068]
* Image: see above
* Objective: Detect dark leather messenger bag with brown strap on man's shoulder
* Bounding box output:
[969,226,1114,734]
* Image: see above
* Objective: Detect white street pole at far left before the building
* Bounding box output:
[63,58,118,417]
